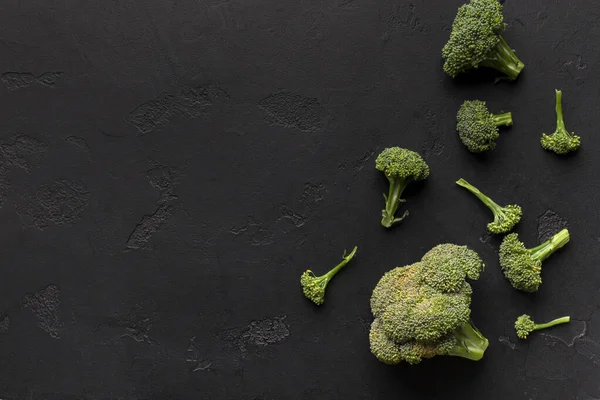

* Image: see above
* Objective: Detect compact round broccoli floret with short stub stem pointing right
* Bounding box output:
[456,100,512,153]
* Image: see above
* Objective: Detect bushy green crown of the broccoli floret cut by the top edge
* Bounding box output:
[442,0,506,78]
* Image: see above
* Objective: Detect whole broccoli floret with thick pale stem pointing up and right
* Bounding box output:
[499,229,570,293]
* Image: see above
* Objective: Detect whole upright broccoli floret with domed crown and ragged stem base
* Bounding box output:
[375,147,429,228]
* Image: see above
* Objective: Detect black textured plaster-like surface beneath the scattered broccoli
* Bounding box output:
[0,0,600,400]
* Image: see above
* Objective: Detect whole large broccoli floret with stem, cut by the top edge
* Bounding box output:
[442,0,525,80]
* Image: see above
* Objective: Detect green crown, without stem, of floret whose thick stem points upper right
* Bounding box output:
[499,233,542,292]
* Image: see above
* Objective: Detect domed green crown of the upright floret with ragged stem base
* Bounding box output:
[375,147,429,181]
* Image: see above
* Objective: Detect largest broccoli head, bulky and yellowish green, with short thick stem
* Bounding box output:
[369,244,488,364]
